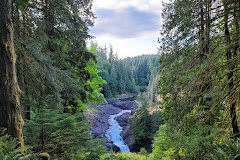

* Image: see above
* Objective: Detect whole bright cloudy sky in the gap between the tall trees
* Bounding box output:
[90,0,162,58]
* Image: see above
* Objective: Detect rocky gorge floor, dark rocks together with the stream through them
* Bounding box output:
[90,94,136,152]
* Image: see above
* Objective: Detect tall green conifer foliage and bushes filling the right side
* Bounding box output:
[153,0,239,159]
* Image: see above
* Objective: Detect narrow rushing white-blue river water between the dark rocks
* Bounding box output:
[106,110,131,152]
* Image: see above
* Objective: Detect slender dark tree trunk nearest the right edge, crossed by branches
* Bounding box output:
[223,0,239,137]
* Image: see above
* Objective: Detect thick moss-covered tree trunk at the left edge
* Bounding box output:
[0,0,24,147]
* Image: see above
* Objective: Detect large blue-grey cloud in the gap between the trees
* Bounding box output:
[91,7,160,39]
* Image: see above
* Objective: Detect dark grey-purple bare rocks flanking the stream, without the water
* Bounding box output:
[90,96,136,152]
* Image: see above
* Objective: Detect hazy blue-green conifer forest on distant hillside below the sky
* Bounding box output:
[91,43,159,98]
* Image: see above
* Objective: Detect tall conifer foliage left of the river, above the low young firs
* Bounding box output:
[14,0,104,110]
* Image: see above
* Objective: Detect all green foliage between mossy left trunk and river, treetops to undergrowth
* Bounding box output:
[8,0,106,159]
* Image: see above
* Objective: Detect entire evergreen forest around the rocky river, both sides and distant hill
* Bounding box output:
[0,0,240,160]
